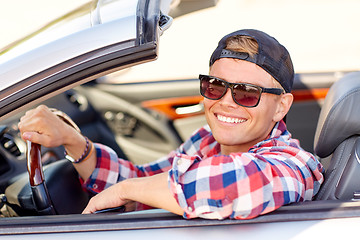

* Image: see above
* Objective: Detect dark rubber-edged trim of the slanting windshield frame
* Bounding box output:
[0,0,161,119]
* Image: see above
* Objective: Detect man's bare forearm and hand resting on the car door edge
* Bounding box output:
[83,172,183,215]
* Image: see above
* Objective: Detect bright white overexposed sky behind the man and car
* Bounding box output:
[0,0,360,80]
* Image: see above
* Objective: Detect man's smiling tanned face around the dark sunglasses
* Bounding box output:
[204,58,283,154]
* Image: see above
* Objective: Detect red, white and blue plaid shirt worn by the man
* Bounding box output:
[85,121,323,219]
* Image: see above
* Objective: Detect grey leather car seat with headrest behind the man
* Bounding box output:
[314,72,360,200]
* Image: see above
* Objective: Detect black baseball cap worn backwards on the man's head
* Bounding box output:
[210,29,295,92]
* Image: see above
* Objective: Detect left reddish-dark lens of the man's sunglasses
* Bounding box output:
[201,77,226,100]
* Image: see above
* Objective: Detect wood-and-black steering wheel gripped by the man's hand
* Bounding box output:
[26,109,87,215]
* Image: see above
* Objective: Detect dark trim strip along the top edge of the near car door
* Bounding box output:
[0,200,360,235]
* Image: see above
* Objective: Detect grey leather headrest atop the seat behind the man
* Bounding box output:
[314,72,360,158]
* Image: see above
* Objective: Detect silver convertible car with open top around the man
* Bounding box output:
[0,0,360,239]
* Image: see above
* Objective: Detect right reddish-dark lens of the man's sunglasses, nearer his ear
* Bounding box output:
[234,84,260,107]
